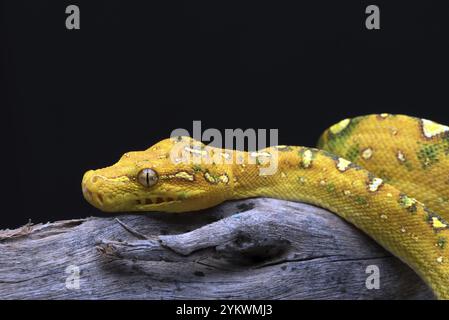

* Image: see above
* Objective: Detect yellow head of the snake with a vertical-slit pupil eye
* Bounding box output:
[82,137,232,212]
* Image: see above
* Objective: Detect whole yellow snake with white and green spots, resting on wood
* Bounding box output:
[81,113,449,299]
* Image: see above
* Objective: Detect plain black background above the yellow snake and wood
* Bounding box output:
[0,0,449,228]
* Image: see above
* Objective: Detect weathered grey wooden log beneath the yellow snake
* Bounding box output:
[0,199,433,299]
